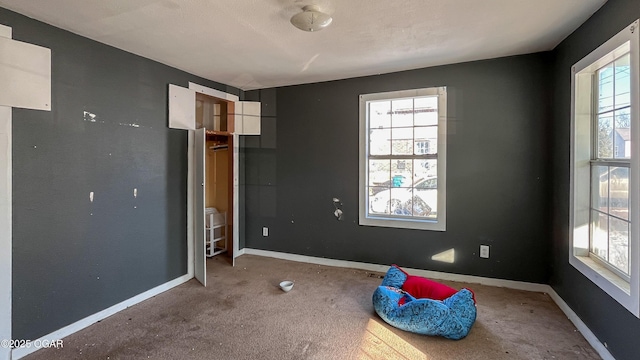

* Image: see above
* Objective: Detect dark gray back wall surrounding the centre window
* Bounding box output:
[244,53,550,283]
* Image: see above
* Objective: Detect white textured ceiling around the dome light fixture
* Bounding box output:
[0,0,606,90]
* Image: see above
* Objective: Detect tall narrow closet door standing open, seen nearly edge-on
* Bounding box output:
[193,129,206,286]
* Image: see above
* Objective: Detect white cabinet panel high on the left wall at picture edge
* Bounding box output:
[0,36,51,110]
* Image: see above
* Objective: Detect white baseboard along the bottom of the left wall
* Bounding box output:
[11,274,193,359]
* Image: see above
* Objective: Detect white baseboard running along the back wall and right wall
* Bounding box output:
[241,248,615,360]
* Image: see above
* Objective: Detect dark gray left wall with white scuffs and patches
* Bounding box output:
[0,8,241,339]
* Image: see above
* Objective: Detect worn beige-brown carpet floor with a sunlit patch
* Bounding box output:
[25,255,599,360]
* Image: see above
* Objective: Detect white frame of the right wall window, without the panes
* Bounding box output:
[569,20,640,317]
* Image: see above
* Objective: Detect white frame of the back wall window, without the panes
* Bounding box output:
[358,87,447,231]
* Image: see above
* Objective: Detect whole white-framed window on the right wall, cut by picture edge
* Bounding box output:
[569,21,640,317]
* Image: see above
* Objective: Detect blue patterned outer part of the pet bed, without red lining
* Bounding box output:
[373,266,476,340]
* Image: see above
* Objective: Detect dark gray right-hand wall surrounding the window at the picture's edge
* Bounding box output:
[549,0,640,360]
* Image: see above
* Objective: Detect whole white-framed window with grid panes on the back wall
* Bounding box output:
[360,87,447,231]
